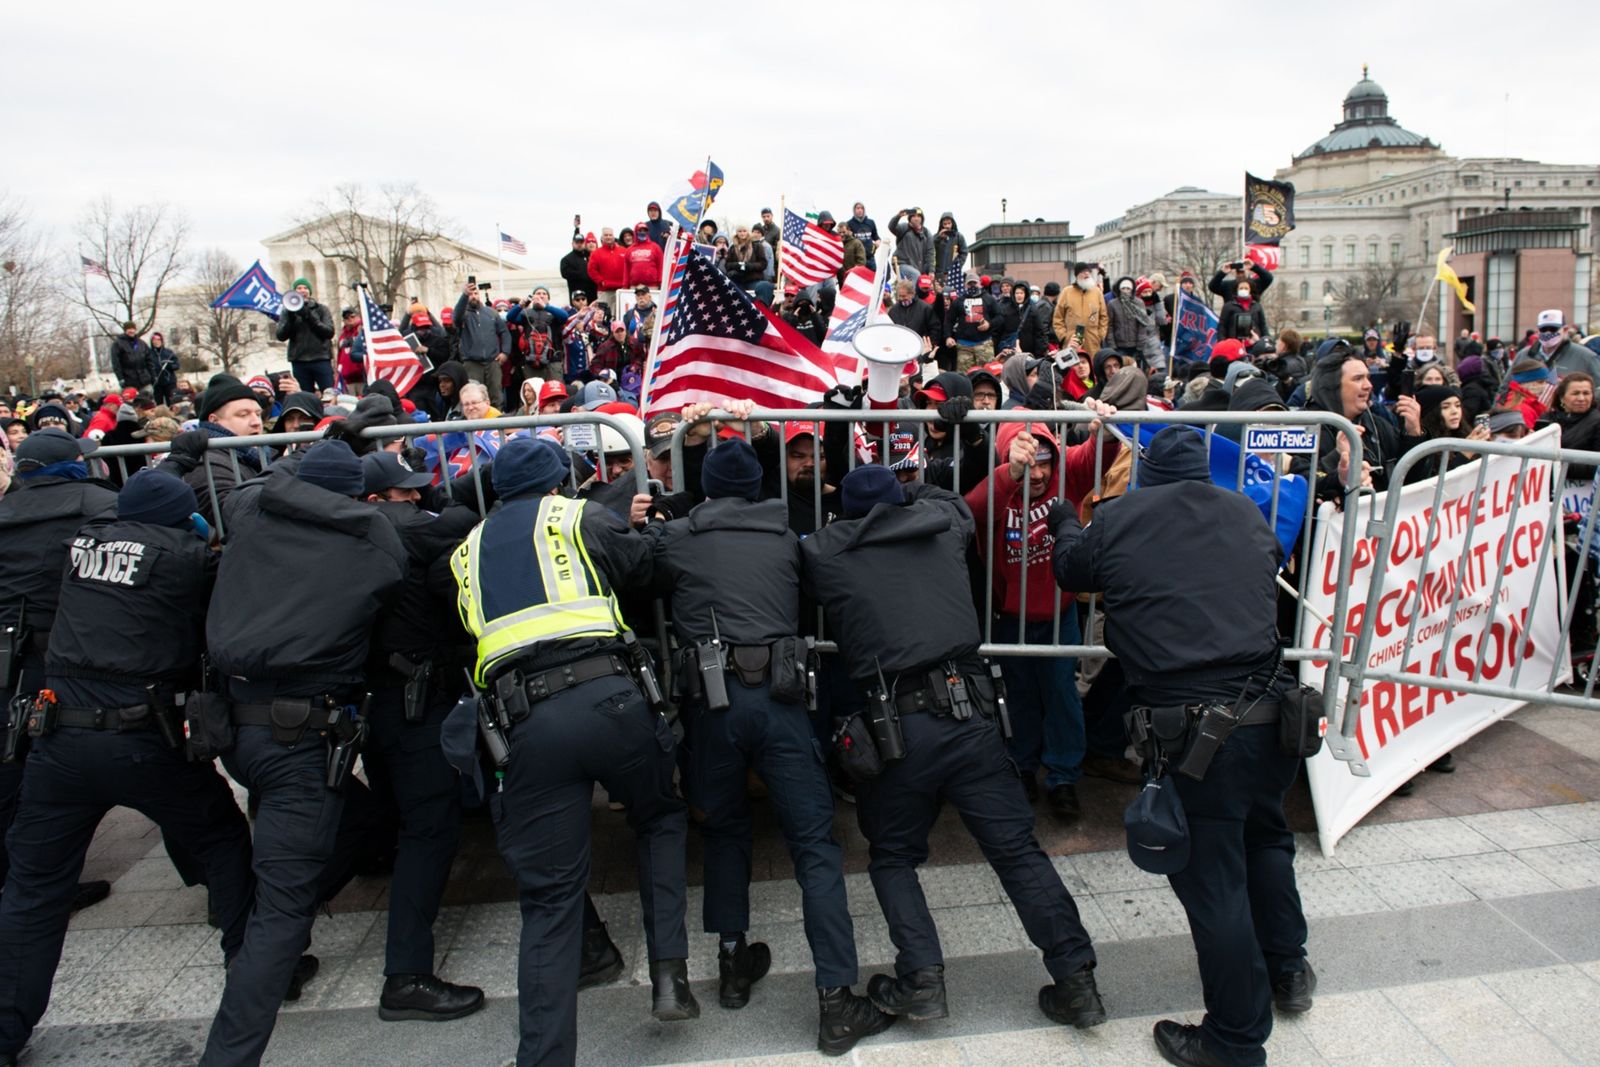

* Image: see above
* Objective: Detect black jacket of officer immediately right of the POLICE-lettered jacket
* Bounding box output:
[206,472,406,696]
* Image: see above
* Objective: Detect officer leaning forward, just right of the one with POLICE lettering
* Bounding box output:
[200,442,406,1067]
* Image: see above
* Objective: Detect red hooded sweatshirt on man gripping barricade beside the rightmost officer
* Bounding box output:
[966,422,1122,622]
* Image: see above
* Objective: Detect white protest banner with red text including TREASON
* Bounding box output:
[1301,429,1571,854]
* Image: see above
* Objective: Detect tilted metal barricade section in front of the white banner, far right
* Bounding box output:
[1341,438,1600,716]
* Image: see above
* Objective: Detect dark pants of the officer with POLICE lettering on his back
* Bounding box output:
[0,728,253,1054]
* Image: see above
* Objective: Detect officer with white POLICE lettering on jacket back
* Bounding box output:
[0,470,254,1064]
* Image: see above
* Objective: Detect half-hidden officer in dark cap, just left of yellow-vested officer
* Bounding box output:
[362,451,483,1022]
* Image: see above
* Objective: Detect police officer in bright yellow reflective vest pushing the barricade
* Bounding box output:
[451,438,699,1067]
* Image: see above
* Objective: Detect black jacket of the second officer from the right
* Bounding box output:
[800,485,982,681]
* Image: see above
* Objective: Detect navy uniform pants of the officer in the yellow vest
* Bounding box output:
[490,675,684,1067]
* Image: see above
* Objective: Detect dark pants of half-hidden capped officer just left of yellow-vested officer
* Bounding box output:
[362,675,461,974]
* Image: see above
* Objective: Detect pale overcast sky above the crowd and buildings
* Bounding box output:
[0,0,1600,285]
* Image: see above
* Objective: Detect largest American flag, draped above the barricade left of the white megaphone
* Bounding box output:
[642,248,837,419]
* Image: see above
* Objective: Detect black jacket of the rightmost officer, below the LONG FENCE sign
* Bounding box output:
[1051,482,1283,701]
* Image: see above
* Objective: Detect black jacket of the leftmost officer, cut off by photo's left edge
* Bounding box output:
[0,478,117,652]
